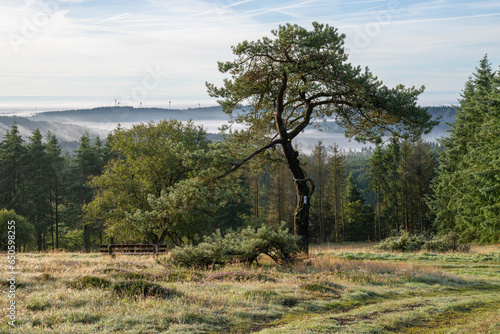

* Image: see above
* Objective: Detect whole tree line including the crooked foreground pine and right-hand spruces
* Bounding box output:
[0,23,500,252]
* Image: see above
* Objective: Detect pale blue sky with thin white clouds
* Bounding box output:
[0,0,500,113]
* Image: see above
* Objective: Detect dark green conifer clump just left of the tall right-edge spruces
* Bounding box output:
[369,137,436,239]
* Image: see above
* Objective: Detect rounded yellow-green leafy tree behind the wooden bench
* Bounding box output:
[86,120,208,243]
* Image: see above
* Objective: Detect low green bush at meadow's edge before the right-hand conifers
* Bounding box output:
[375,232,470,252]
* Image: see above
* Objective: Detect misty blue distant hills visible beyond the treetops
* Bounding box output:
[0,106,456,152]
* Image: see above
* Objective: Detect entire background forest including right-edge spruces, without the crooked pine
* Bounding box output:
[0,57,500,251]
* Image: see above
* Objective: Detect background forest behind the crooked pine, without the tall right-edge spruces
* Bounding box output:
[0,120,442,251]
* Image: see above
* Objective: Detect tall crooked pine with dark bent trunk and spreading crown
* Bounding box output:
[207,22,435,251]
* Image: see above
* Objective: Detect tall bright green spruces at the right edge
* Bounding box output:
[430,56,500,243]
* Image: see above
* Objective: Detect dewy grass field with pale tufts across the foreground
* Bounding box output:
[0,244,500,334]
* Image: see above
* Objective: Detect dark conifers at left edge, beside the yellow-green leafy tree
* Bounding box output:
[0,128,109,251]
